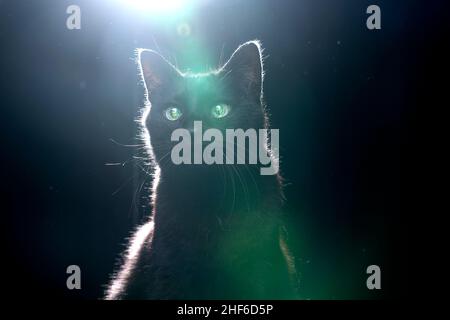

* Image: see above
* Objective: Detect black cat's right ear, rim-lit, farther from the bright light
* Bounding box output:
[222,41,264,101]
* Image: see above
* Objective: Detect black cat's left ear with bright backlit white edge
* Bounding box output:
[138,49,180,92]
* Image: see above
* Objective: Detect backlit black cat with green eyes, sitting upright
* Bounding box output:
[106,41,298,299]
